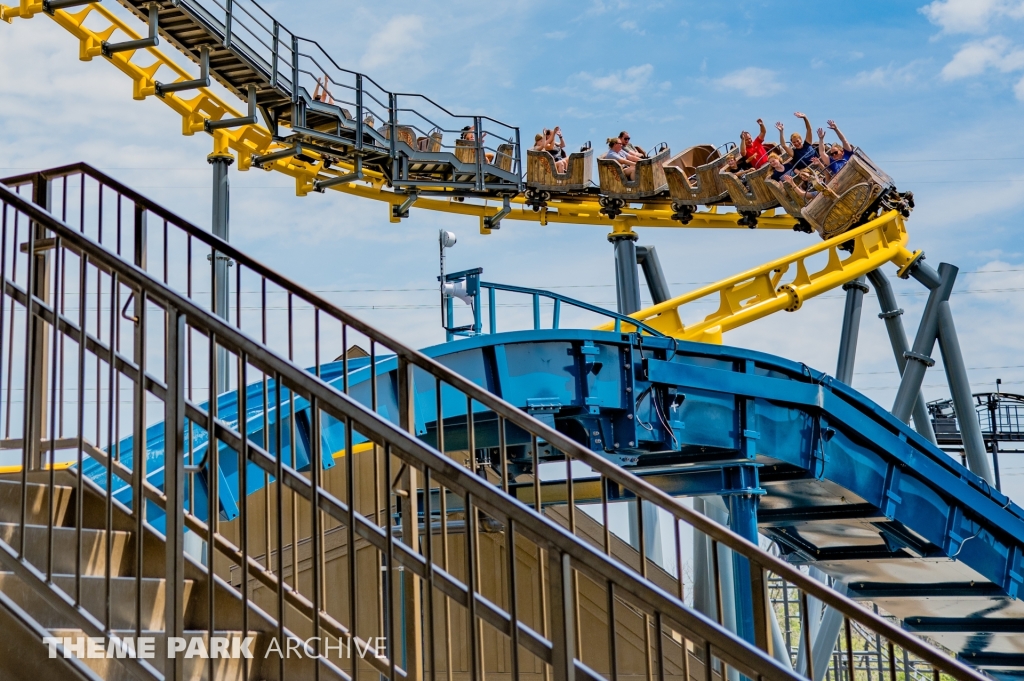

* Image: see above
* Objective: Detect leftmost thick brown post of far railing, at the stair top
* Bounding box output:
[25,173,50,470]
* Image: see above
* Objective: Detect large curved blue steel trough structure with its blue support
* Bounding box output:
[83,329,1024,676]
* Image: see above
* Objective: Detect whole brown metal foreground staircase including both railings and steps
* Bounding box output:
[0,165,981,681]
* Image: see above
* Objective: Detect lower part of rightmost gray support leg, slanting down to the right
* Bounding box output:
[939,302,995,486]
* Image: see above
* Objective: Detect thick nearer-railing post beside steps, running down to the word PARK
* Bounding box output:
[164,307,185,681]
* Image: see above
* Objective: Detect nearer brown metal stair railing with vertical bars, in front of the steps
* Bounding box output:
[0,175,799,681]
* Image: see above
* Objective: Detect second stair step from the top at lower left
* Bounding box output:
[0,522,134,577]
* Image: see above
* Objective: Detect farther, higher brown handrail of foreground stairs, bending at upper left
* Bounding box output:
[2,164,983,679]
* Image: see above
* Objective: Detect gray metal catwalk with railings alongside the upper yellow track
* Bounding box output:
[109,0,522,199]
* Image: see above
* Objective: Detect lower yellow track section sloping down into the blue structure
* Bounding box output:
[597,211,921,343]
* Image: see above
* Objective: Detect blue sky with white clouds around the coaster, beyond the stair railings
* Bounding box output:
[0,0,1024,413]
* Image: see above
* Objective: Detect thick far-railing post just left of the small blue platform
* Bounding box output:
[397,356,419,681]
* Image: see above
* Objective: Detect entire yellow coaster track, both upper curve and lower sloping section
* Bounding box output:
[0,0,921,343]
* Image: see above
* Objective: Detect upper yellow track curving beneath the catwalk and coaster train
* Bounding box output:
[0,0,796,233]
